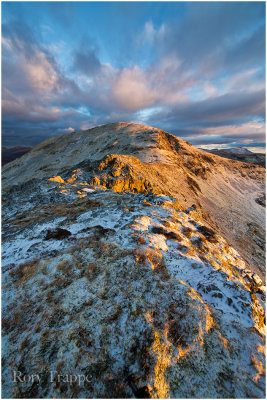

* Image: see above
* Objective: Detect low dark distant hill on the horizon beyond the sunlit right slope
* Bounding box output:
[208,147,266,167]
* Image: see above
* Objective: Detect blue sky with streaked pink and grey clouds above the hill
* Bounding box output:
[1,1,265,152]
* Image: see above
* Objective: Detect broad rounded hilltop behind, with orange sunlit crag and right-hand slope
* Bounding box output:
[2,123,265,276]
